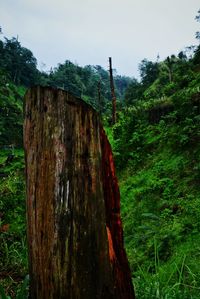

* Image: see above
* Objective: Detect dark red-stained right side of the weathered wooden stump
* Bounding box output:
[101,129,134,299]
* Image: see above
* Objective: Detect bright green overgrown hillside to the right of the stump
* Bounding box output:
[108,40,200,299]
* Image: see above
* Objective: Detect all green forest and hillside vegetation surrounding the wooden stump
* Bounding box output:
[0,10,200,299]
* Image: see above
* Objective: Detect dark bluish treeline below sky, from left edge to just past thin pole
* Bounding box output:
[0,37,132,106]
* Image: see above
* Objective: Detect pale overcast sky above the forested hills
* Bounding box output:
[0,0,200,77]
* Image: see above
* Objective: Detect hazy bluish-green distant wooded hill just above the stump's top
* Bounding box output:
[41,60,131,112]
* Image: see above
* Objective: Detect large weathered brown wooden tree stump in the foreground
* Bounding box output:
[24,87,134,299]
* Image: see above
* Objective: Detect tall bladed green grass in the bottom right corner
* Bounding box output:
[133,239,200,299]
